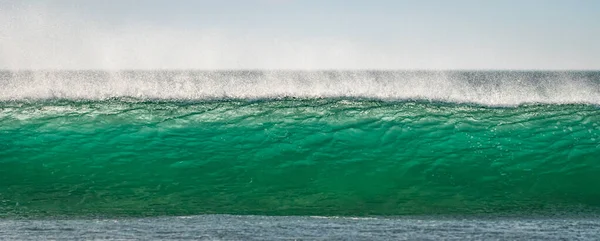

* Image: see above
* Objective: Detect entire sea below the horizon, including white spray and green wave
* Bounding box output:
[0,71,600,240]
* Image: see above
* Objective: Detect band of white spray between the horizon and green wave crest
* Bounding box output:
[0,71,600,106]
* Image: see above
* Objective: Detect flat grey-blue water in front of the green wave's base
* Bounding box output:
[0,215,600,240]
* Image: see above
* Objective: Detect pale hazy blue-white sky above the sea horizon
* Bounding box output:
[0,0,600,69]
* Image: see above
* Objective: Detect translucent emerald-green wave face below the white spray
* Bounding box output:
[0,99,600,217]
